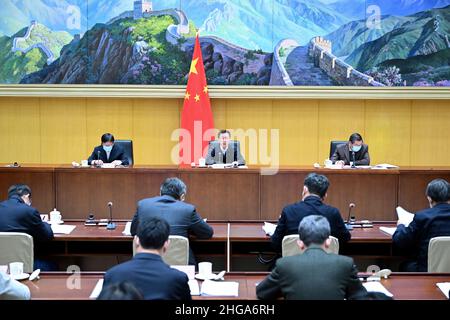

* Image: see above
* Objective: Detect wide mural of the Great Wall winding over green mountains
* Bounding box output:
[0,0,450,86]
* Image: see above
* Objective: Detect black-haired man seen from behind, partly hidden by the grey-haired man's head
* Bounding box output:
[271,173,351,252]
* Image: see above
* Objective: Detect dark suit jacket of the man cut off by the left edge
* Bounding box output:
[0,196,53,243]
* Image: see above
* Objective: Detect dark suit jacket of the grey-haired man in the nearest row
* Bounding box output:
[256,246,366,300]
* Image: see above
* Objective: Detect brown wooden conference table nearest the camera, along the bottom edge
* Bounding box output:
[23,272,450,300]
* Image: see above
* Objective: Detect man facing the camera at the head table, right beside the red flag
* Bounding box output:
[205,130,245,166]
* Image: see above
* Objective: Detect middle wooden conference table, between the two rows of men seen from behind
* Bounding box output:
[45,220,395,271]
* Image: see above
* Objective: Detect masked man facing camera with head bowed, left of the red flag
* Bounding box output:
[88,133,129,166]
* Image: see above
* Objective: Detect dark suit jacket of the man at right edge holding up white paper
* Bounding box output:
[392,203,450,272]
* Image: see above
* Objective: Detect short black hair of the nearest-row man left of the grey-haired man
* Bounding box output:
[136,217,170,250]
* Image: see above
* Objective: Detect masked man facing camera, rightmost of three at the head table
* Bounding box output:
[330,133,370,166]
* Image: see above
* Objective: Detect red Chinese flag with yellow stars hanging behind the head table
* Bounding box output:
[180,34,215,167]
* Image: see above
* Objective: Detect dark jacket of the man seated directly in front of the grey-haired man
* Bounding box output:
[271,196,351,252]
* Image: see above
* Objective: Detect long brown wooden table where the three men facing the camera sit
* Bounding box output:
[0,164,450,221]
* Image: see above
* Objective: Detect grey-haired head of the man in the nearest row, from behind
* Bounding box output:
[298,215,330,247]
